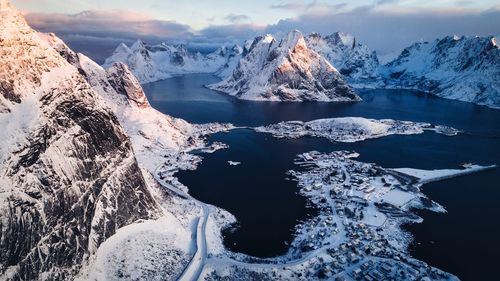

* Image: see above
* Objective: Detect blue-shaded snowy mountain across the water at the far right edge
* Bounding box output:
[382,36,500,108]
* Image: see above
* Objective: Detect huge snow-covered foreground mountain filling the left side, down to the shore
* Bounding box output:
[0,0,236,280]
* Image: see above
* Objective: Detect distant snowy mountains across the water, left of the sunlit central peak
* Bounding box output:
[103,40,242,83]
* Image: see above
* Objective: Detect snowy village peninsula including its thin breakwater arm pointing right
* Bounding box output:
[202,151,494,280]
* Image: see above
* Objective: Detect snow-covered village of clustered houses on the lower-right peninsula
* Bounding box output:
[282,151,453,281]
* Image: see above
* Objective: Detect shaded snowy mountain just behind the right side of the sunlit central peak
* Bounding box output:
[306,32,380,84]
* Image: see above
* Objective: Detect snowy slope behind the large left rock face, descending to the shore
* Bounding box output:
[41,34,232,168]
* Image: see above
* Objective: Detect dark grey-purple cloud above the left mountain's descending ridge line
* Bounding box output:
[25,11,193,62]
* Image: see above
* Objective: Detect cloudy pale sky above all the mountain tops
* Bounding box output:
[11,0,500,61]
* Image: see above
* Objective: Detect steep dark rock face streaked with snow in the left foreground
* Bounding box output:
[0,1,160,280]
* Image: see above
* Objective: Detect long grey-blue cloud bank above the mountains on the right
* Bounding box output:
[267,6,500,54]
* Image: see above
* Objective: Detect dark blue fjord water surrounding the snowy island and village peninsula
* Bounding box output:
[141,74,500,280]
